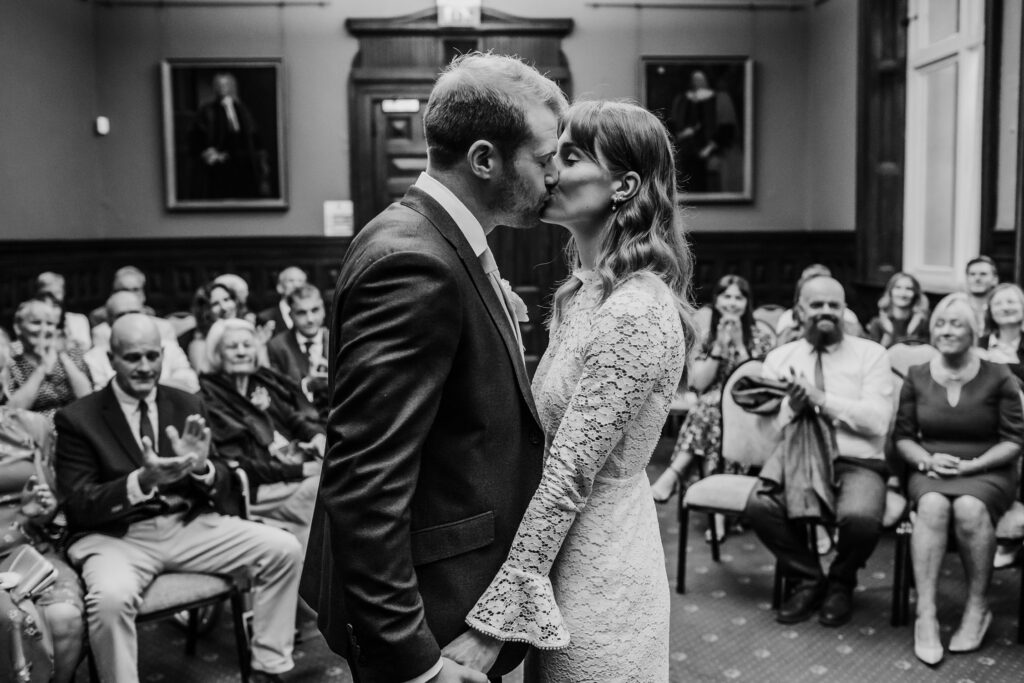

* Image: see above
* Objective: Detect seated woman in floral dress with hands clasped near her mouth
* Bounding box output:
[651,275,772,538]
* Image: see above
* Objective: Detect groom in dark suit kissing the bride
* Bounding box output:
[302,53,566,683]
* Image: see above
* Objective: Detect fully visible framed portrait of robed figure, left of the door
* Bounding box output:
[161,59,288,211]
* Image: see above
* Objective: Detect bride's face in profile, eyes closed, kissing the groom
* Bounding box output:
[541,130,618,228]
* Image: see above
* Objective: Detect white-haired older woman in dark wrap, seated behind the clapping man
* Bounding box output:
[200,317,327,546]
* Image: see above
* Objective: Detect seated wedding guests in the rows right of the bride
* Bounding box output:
[652,257,1024,665]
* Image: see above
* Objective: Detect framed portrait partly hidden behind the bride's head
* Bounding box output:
[640,56,754,204]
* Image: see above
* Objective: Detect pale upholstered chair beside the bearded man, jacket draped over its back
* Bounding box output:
[676,359,780,599]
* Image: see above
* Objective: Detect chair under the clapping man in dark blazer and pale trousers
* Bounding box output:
[89,465,252,683]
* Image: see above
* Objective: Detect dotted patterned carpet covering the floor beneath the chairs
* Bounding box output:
[78,439,1024,683]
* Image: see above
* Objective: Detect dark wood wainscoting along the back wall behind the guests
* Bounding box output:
[0,231,869,330]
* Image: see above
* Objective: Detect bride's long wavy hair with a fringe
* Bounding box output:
[550,100,696,353]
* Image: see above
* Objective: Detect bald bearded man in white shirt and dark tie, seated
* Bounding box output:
[744,276,893,626]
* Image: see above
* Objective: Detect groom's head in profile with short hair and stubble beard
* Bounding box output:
[423,52,568,230]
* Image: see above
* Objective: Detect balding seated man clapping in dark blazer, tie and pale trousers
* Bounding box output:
[55,313,302,683]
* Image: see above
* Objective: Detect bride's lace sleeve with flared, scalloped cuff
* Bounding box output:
[466,287,682,649]
